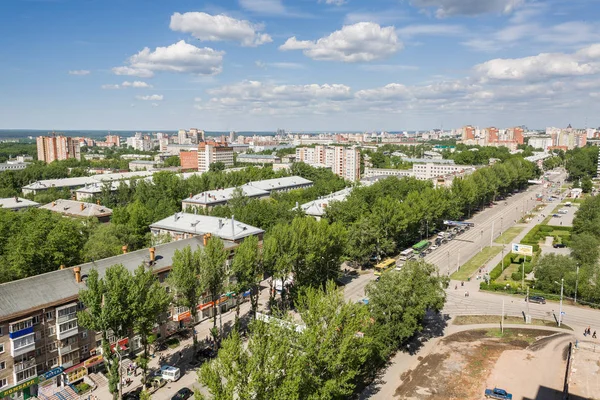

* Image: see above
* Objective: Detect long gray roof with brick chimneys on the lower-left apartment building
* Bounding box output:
[0,236,236,321]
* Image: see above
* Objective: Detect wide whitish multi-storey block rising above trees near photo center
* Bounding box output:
[296,146,360,181]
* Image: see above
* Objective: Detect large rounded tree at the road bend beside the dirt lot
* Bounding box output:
[366,261,447,355]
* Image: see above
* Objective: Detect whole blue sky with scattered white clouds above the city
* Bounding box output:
[0,0,600,132]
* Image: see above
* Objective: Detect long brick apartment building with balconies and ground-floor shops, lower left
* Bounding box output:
[0,236,237,400]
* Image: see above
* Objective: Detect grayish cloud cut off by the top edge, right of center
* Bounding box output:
[411,0,525,18]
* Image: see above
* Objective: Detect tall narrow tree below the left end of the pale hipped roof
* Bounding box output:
[168,246,206,354]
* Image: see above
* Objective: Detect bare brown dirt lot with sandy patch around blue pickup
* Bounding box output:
[395,329,571,400]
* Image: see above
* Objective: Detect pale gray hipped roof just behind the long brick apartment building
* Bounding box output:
[150,212,264,241]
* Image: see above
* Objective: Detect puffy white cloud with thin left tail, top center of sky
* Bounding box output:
[279,22,402,62]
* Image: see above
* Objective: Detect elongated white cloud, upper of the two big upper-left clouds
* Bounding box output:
[170,12,273,47]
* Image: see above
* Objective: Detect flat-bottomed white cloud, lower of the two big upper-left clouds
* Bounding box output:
[113,40,225,77]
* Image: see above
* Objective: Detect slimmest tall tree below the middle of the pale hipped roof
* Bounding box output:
[200,237,228,337]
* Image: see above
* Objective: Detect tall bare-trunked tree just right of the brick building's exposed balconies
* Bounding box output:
[130,265,171,382]
